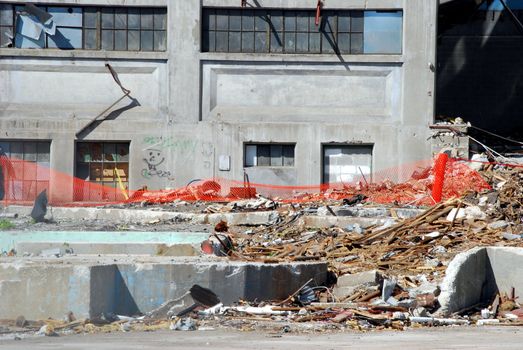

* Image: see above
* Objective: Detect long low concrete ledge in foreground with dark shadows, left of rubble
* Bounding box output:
[0,256,327,319]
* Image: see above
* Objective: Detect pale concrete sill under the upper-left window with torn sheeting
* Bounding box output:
[0,48,169,60]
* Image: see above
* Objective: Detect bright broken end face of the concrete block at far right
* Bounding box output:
[438,247,488,317]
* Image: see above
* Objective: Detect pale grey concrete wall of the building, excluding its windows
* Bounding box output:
[0,0,437,196]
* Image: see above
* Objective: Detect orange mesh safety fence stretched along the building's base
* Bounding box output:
[0,156,496,206]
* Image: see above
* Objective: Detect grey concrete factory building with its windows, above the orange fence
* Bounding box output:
[0,0,438,200]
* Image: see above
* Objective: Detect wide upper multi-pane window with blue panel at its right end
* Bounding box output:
[202,8,403,54]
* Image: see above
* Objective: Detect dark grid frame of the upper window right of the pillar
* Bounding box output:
[200,7,404,56]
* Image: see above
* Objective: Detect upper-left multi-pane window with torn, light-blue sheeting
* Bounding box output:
[0,4,167,51]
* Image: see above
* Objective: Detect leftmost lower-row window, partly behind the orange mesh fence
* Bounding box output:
[0,140,51,200]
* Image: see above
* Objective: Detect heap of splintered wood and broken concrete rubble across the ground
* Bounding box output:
[0,158,523,336]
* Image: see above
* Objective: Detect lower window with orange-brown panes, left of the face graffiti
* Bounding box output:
[74,142,129,201]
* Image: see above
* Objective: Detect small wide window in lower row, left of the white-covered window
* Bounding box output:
[244,143,295,168]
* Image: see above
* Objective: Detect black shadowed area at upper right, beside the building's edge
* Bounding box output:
[436,0,523,138]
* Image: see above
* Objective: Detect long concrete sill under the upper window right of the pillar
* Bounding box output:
[200,52,405,64]
